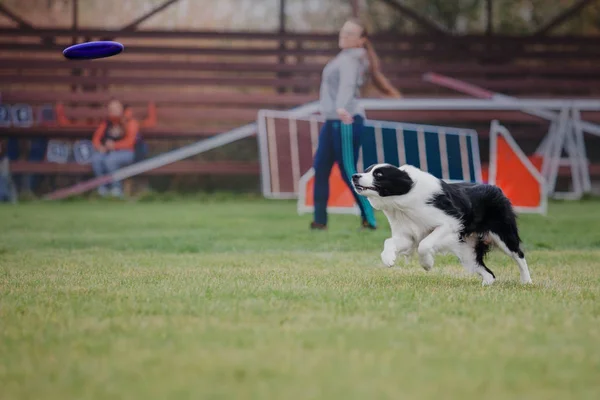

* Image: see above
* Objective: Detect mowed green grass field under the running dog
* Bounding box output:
[0,200,600,400]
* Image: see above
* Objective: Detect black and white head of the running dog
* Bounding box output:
[352,164,415,198]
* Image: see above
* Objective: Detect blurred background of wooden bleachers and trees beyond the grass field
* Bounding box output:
[0,0,600,198]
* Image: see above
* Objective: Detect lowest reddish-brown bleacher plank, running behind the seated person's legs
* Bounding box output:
[9,160,260,175]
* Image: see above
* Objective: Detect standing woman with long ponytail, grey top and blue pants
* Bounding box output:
[310,19,400,229]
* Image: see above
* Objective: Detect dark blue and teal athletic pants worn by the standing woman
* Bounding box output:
[313,115,376,226]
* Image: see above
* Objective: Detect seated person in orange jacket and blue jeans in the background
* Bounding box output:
[92,100,139,197]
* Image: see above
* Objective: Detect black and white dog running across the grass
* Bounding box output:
[352,164,531,285]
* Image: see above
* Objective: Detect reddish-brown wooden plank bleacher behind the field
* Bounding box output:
[0,28,600,191]
